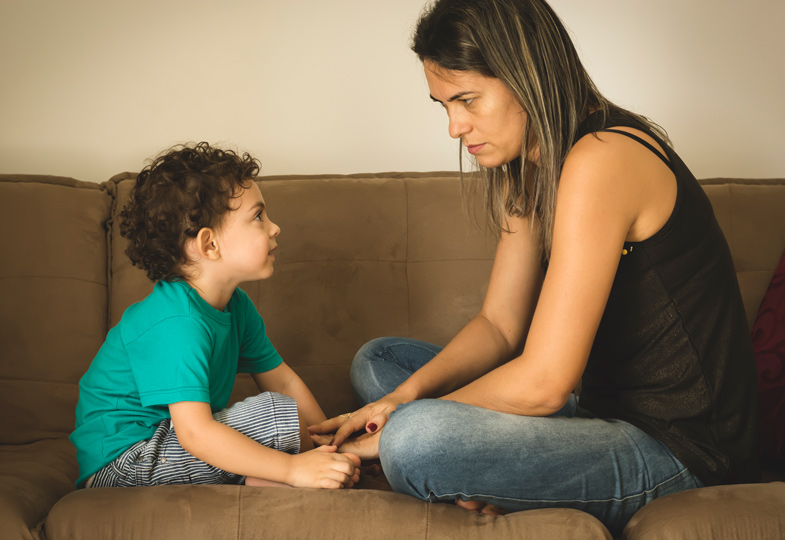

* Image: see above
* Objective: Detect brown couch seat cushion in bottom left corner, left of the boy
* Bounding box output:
[0,439,77,540]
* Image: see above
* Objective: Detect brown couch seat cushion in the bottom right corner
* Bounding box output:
[622,482,785,540]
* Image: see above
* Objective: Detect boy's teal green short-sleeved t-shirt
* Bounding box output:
[69,281,282,487]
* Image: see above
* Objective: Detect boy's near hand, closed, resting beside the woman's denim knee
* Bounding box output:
[286,446,360,489]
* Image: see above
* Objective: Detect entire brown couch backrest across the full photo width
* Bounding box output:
[0,173,785,444]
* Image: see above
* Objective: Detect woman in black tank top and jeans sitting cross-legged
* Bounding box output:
[311,0,758,535]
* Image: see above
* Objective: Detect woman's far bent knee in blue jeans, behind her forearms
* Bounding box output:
[350,337,442,405]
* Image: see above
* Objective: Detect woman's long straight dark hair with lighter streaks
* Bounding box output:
[412,0,668,260]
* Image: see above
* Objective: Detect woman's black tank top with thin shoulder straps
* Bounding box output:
[576,109,760,485]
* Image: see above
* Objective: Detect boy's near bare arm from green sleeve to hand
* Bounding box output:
[169,401,359,489]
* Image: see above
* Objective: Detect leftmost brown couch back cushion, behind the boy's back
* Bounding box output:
[0,175,111,444]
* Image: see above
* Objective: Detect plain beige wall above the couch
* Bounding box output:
[0,0,785,182]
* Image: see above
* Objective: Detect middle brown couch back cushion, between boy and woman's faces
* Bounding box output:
[109,173,494,415]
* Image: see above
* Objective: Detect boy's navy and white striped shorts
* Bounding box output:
[88,392,300,488]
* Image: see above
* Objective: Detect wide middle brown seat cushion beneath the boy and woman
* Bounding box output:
[46,486,611,540]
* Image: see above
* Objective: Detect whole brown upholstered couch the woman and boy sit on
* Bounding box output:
[0,173,785,540]
